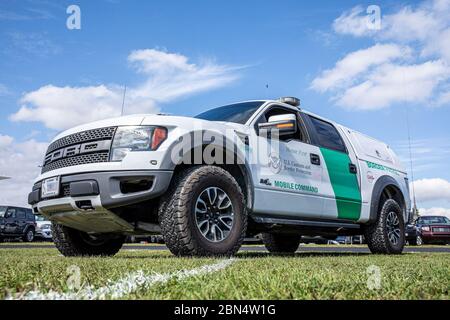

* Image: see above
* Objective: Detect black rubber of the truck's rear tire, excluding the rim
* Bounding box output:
[365,199,405,254]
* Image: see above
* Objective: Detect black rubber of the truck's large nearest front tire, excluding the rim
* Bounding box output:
[158,165,247,256]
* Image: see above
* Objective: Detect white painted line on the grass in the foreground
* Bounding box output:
[6,259,234,300]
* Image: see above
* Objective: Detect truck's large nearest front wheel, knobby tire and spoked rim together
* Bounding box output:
[159,166,247,256]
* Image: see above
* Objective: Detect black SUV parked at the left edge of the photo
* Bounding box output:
[0,206,36,242]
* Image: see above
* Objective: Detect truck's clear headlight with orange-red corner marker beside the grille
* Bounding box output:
[111,126,167,161]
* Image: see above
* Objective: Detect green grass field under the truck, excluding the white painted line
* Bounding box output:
[0,249,450,300]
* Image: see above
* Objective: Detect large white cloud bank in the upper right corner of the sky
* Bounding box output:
[311,0,450,110]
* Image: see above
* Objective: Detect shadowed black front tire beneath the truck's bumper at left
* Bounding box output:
[52,222,125,257]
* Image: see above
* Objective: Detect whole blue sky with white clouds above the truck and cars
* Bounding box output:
[0,0,450,213]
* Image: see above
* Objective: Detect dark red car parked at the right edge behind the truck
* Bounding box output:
[416,216,450,244]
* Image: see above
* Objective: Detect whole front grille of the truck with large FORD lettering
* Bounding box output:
[41,127,117,173]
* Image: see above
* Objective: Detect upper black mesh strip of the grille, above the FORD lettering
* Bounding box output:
[46,127,117,154]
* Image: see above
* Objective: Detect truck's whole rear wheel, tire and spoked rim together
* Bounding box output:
[365,199,405,254]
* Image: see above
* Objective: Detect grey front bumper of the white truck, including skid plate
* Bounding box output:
[28,170,173,233]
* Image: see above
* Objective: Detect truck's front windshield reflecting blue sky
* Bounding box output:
[195,101,264,124]
